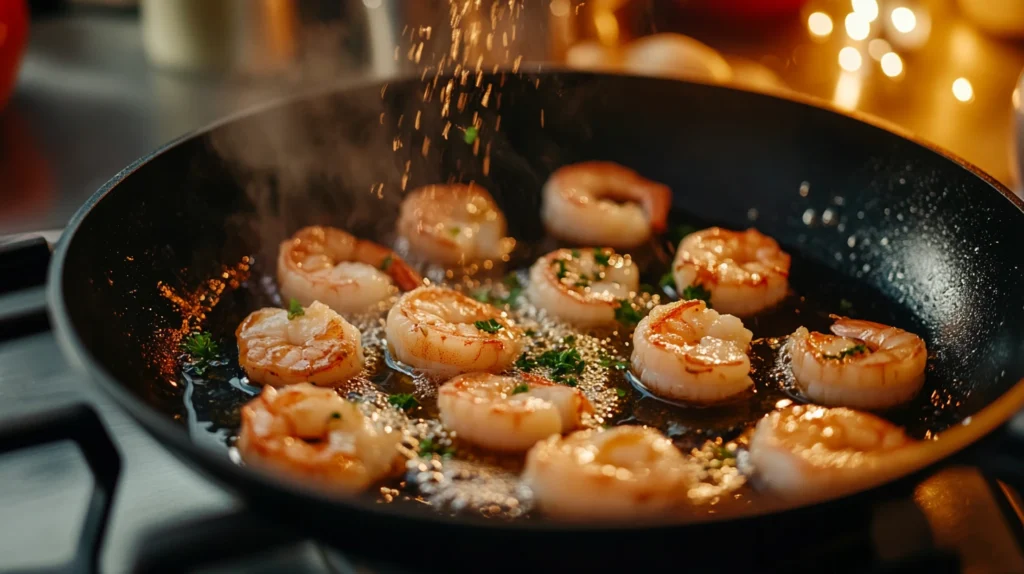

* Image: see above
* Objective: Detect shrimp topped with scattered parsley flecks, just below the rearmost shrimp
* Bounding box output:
[526,248,640,326]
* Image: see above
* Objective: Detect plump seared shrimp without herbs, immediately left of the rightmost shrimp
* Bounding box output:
[633,301,754,402]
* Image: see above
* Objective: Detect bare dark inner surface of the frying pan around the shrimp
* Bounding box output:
[62,74,1024,519]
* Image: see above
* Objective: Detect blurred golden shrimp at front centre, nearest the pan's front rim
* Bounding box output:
[522,427,695,520]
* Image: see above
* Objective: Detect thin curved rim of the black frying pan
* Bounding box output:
[46,70,1024,533]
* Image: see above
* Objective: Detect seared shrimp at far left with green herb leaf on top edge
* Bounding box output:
[234,301,362,387]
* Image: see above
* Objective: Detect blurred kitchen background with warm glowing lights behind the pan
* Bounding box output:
[0,0,1024,235]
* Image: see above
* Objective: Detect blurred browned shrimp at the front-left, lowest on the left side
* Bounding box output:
[238,384,401,494]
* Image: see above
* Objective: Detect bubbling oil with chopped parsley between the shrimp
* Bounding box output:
[181,224,953,519]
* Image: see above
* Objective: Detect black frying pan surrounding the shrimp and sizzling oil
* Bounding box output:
[49,73,1024,568]
